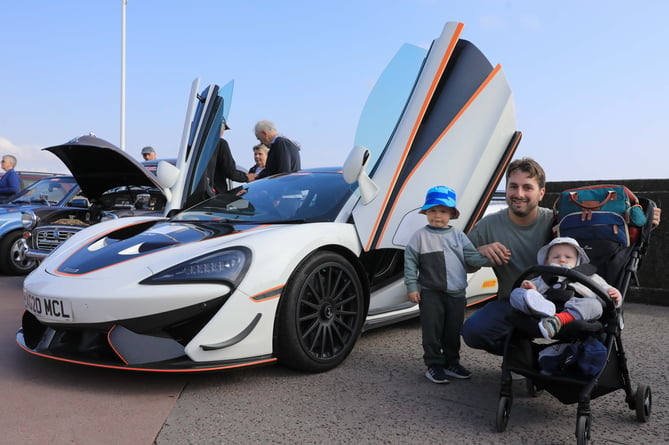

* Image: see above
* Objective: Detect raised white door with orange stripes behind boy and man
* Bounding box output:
[353,23,520,251]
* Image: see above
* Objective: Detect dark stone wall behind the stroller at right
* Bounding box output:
[541,179,669,306]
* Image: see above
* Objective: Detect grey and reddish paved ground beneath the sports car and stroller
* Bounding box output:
[0,277,669,445]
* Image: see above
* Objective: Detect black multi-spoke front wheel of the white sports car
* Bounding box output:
[276,252,365,372]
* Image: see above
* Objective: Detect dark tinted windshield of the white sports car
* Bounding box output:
[173,171,351,224]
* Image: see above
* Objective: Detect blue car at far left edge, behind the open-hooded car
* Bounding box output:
[0,175,84,275]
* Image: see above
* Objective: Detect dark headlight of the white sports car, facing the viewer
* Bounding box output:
[140,247,251,287]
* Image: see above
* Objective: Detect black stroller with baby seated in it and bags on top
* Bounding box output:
[496,185,655,444]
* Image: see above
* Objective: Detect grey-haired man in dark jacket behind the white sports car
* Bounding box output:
[254,120,301,179]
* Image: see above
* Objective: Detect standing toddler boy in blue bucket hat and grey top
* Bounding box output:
[404,186,490,383]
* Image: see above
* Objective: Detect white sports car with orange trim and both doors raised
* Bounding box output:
[17,23,520,372]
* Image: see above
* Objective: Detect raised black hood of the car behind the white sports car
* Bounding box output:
[44,135,162,199]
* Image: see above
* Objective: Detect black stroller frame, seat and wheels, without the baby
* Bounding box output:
[496,192,655,445]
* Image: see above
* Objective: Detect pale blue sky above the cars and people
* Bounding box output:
[0,0,669,180]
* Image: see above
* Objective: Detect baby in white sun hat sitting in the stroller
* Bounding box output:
[511,237,622,339]
